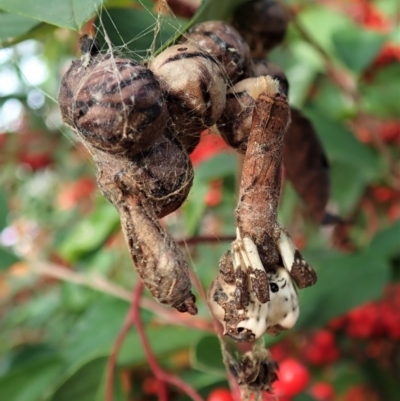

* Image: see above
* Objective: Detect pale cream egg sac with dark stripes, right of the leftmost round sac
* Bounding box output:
[149,43,226,152]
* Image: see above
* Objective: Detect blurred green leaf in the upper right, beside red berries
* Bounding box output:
[332,25,386,73]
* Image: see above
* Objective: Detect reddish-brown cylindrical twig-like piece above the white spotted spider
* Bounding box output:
[236,94,290,268]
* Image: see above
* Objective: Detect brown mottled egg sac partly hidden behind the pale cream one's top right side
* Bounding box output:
[184,21,252,84]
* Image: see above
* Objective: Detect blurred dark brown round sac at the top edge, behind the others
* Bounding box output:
[233,0,289,57]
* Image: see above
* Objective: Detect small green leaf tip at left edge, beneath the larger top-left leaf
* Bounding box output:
[0,12,40,47]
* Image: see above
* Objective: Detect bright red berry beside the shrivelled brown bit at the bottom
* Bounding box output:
[273,358,310,397]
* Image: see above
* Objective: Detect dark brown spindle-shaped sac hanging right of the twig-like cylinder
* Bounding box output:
[283,109,330,223]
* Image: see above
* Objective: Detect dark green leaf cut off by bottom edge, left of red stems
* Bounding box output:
[50,357,108,401]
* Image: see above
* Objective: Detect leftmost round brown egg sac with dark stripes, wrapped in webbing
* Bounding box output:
[59,54,168,155]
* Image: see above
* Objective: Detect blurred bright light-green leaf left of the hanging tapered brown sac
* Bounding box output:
[59,202,120,263]
